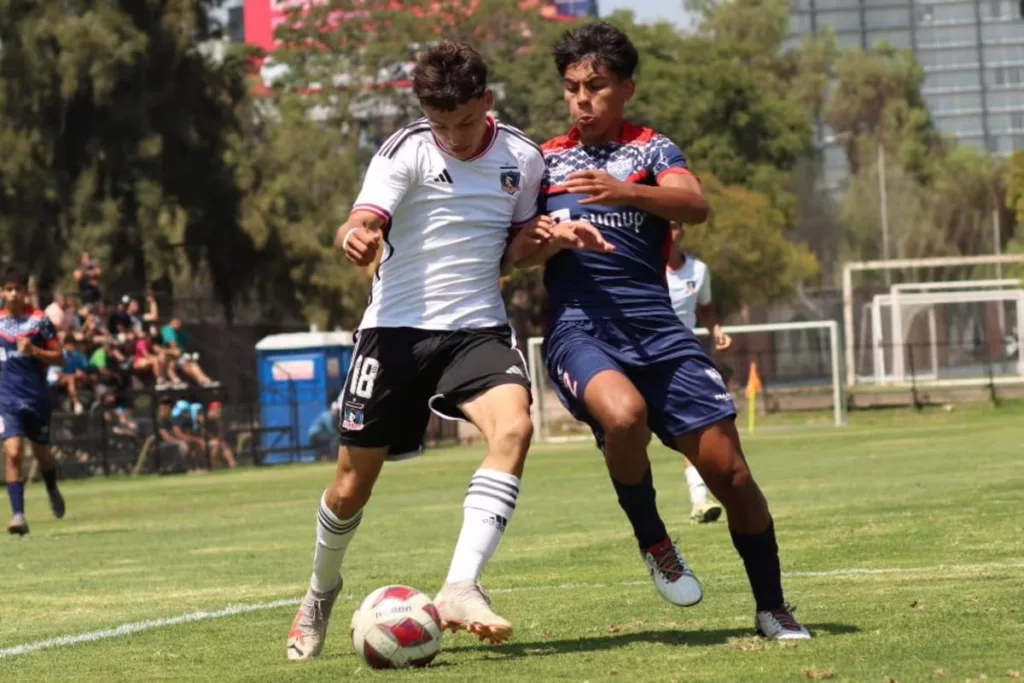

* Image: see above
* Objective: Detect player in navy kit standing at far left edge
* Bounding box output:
[0,268,65,536]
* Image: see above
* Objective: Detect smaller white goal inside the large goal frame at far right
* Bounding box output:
[858,280,1024,386]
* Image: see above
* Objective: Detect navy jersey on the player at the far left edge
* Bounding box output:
[0,308,57,411]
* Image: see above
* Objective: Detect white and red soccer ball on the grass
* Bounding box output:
[351,586,442,669]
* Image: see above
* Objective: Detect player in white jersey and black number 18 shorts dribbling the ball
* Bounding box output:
[287,43,602,659]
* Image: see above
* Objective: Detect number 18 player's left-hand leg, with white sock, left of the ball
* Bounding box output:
[287,445,388,660]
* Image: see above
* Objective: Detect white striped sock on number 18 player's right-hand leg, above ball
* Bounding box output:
[446,468,520,584]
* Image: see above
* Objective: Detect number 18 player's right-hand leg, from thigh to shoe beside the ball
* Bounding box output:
[434,384,534,643]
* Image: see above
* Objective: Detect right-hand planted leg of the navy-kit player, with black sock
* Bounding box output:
[676,419,811,640]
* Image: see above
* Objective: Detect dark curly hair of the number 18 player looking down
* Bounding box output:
[413,41,487,112]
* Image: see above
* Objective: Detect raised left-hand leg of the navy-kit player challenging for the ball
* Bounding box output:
[584,370,703,606]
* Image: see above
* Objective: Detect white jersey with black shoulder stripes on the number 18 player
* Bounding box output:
[352,119,544,330]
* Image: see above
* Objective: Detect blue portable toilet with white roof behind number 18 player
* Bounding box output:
[256,332,354,465]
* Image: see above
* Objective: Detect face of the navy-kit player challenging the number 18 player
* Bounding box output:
[562,60,636,142]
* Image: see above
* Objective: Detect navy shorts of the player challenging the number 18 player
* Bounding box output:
[544,317,736,449]
